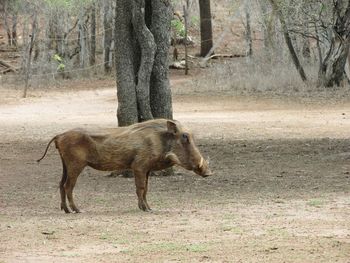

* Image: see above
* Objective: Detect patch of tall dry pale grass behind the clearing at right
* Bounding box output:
[175,56,350,103]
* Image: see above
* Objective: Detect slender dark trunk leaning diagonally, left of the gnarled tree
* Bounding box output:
[269,0,307,81]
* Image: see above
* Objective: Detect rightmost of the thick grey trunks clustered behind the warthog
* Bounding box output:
[150,0,173,119]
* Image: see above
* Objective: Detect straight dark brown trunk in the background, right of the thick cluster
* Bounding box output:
[199,0,213,57]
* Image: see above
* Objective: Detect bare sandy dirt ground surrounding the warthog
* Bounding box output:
[0,77,350,263]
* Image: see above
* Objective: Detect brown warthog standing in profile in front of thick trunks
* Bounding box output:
[38,119,211,213]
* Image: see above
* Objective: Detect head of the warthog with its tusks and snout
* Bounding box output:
[167,121,212,177]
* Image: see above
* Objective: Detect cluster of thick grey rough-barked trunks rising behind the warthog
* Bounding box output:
[115,0,172,125]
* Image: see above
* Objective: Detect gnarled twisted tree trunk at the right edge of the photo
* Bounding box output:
[318,0,350,87]
